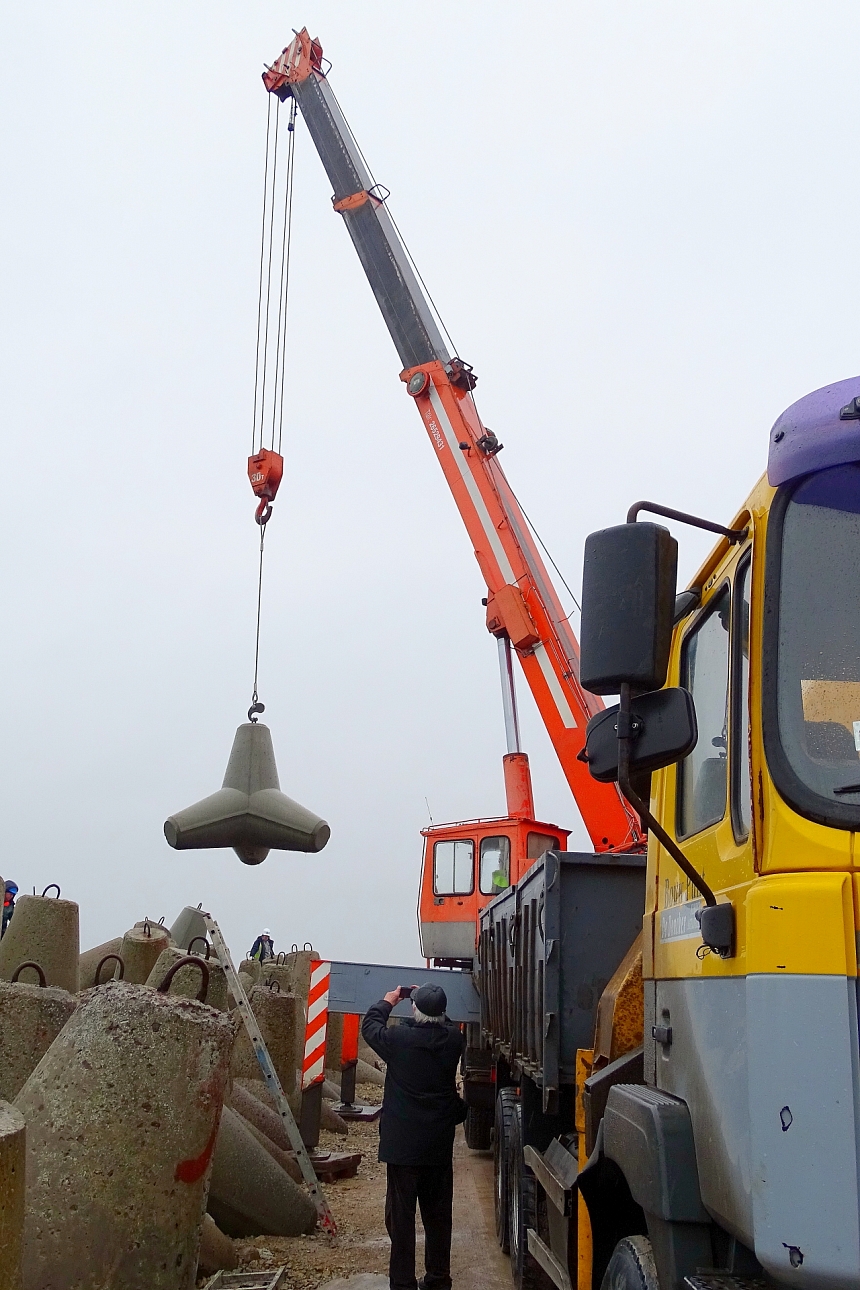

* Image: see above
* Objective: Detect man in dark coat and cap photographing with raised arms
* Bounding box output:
[361,986,463,1290]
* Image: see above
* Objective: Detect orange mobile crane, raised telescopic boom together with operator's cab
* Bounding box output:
[263,30,645,966]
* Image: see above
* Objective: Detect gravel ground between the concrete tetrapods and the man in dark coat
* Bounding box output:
[197,1084,389,1290]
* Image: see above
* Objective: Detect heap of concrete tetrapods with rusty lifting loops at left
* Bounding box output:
[0,894,379,1290]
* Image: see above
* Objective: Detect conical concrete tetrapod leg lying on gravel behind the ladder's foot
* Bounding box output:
[208,1107,316,1233]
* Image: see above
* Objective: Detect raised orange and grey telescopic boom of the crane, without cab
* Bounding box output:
[263,30,643,851]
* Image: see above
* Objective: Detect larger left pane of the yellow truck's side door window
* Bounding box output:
[678,586,731,837]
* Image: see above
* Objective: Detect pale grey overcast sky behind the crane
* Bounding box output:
[0,0,860,962]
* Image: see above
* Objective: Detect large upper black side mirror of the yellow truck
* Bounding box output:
[579,524,678,694]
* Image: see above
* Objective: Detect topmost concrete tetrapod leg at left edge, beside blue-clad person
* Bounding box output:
[0,895,81,995]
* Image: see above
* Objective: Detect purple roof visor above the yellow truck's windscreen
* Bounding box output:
[767,377,860,486]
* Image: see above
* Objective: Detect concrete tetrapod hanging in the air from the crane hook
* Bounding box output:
[164,721,331,864]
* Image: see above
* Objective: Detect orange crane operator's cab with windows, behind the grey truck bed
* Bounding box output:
[418,752,570,968]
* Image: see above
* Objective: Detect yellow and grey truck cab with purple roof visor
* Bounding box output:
[583,378,860,1290]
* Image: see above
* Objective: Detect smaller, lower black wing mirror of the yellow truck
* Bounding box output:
[584,686,699,784]
